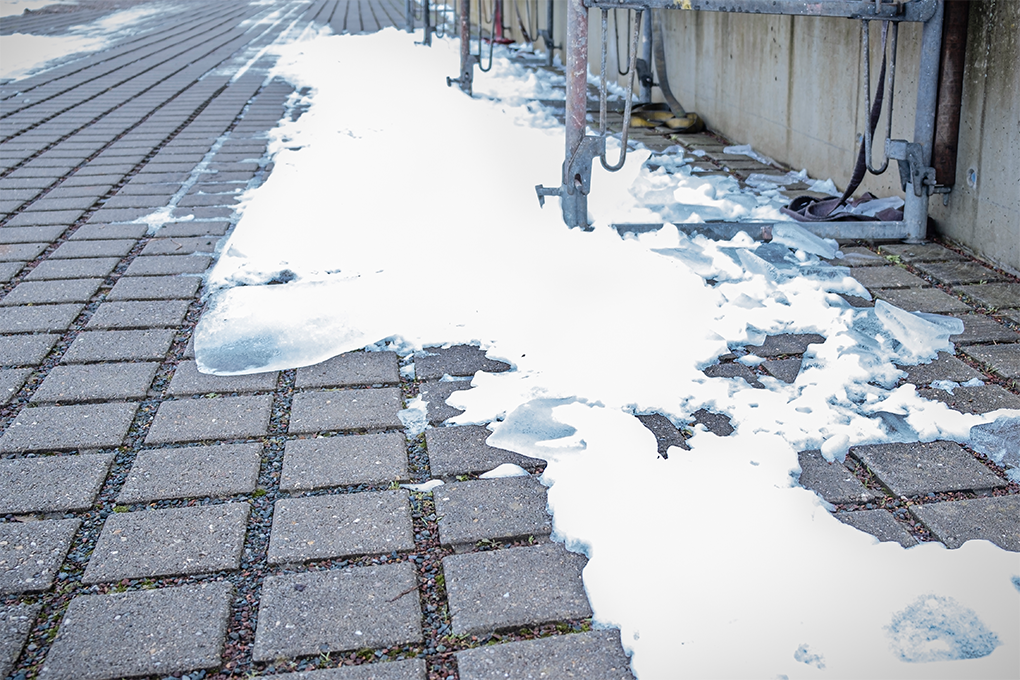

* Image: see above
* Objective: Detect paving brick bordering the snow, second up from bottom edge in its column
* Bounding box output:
[443,543,592,635]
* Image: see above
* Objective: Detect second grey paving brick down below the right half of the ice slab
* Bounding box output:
[289,387,403,434]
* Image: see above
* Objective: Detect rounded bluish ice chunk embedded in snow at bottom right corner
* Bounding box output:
[886,595,1001,664]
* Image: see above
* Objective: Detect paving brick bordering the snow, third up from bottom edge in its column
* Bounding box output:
[432,477,553,547]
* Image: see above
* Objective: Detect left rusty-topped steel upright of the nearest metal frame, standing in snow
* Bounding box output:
[560,0,591,228]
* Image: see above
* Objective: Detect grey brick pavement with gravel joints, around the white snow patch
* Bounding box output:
[0,0,1020,680]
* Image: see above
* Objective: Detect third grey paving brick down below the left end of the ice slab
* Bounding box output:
[117,443,262,503]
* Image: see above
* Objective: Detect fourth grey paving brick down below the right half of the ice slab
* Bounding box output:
[269,489,414,564]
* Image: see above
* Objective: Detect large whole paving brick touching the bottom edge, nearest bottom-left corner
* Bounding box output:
[39,581,234,680]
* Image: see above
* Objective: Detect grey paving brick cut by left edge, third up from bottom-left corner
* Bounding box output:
[0,454,113,515]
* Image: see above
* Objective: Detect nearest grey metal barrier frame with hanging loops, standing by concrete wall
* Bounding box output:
[536,0,946,243]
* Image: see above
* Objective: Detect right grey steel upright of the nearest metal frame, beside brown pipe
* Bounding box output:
[903,0,945,243]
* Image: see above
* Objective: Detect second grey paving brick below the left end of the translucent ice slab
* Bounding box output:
[144,396,272,444]
